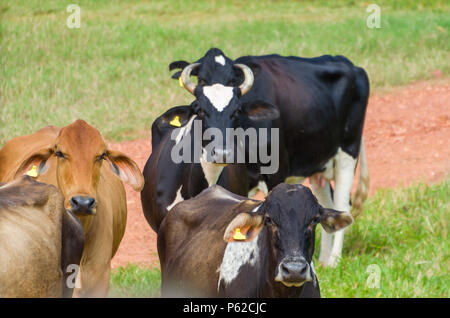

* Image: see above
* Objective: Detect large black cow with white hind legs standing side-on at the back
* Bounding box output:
[169,48,369,266]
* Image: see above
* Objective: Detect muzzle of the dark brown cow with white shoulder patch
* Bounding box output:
[275,256,313,287]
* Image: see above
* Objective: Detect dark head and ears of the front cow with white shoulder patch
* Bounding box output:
[224,183,353,287]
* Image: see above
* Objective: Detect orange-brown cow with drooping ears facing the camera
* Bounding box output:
[0,120,144,297]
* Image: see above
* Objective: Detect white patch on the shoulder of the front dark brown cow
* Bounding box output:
[217,234,259,289]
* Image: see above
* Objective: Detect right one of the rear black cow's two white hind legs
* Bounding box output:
[326,149,357,267]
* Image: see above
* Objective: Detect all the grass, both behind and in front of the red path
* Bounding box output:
[0,0,450,297]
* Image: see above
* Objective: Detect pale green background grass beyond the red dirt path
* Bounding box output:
[0,0,450,145]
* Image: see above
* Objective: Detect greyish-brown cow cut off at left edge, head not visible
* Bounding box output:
[0,176,84,297]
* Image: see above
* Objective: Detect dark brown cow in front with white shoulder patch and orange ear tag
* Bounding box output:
[157,183,353,298]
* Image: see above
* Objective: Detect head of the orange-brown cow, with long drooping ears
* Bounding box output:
[16,120,144,215]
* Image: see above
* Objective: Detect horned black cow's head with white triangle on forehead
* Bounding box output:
[170,49,279,163]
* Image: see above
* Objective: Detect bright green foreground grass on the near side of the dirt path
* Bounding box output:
[110,181,450,298]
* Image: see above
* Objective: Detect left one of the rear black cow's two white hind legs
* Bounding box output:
[310,178,334,264]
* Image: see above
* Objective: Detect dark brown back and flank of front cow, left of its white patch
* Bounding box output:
[158,186,261,297]
